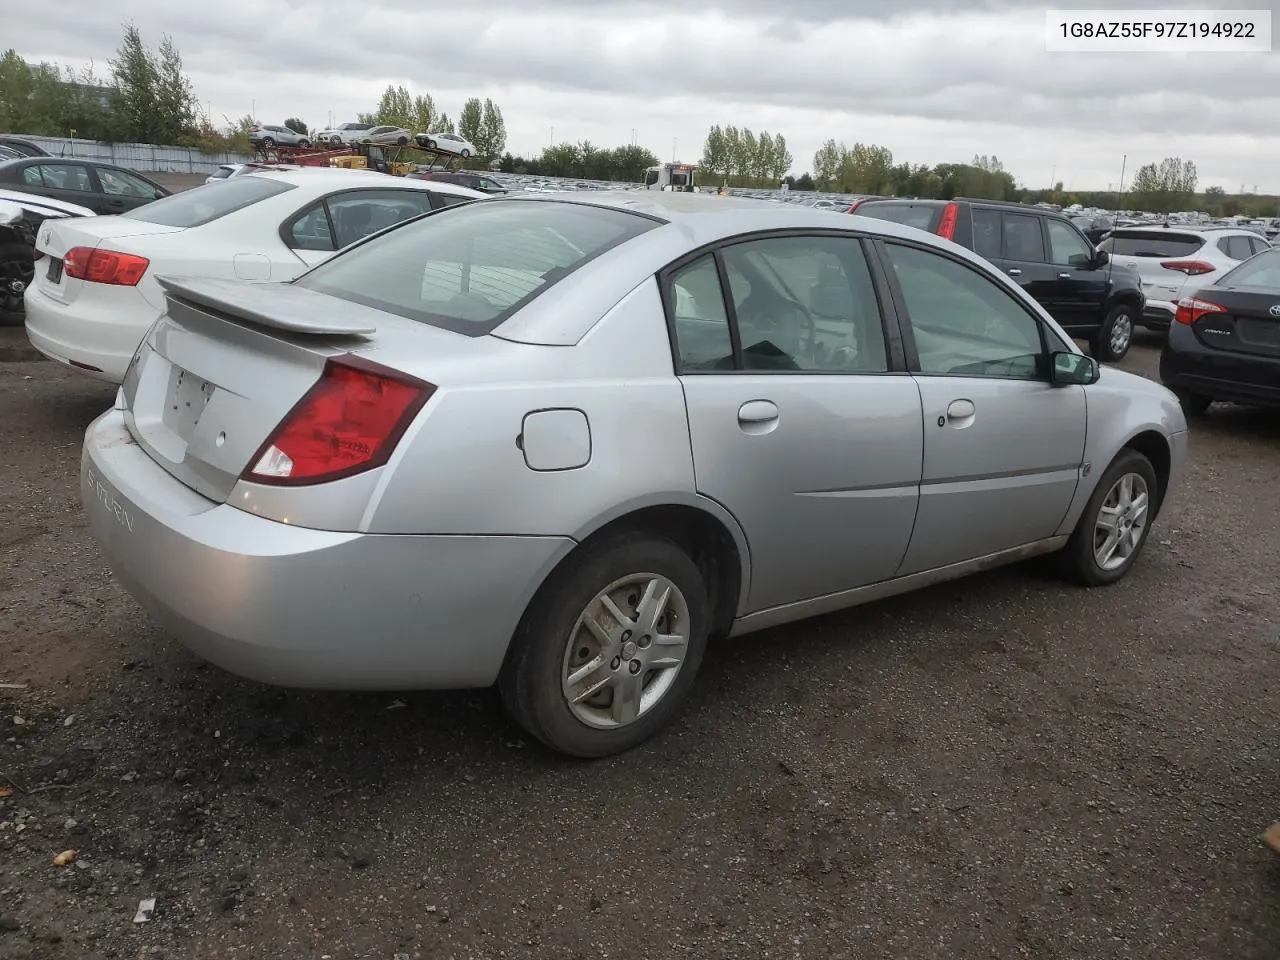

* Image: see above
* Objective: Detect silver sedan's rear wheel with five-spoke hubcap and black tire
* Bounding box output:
[498,531,709,758]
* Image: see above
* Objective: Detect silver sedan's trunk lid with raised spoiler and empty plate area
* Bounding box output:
[122,278,483,503]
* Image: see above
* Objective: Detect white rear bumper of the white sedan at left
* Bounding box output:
[24,282,159,384]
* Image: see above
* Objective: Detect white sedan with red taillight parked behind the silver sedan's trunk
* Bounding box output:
[26,168,486,384]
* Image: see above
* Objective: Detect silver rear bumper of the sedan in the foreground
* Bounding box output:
[81,410,573,690]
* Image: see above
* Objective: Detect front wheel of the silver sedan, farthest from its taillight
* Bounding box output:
[1062,449,1158,586]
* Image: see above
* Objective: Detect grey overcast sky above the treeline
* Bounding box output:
[10,0,1280,193]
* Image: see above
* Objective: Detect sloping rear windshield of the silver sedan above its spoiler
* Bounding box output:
[297,200,657,337]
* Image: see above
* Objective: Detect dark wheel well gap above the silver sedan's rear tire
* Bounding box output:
[570,503,742,637]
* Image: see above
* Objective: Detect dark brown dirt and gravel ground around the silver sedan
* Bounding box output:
[0,335,1280,960]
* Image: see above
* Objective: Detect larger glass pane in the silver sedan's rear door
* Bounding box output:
[723,237,888,374]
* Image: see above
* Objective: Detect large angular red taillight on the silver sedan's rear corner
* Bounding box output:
[243,355,435,486]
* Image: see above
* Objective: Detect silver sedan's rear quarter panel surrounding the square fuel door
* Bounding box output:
[362,278,696,539]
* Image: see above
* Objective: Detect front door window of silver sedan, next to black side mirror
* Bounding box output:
[886,243,1043,380]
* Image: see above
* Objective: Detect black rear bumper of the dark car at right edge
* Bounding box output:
[1160,324,1280,406]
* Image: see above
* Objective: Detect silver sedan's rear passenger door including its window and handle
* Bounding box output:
[664,236,922,612]
